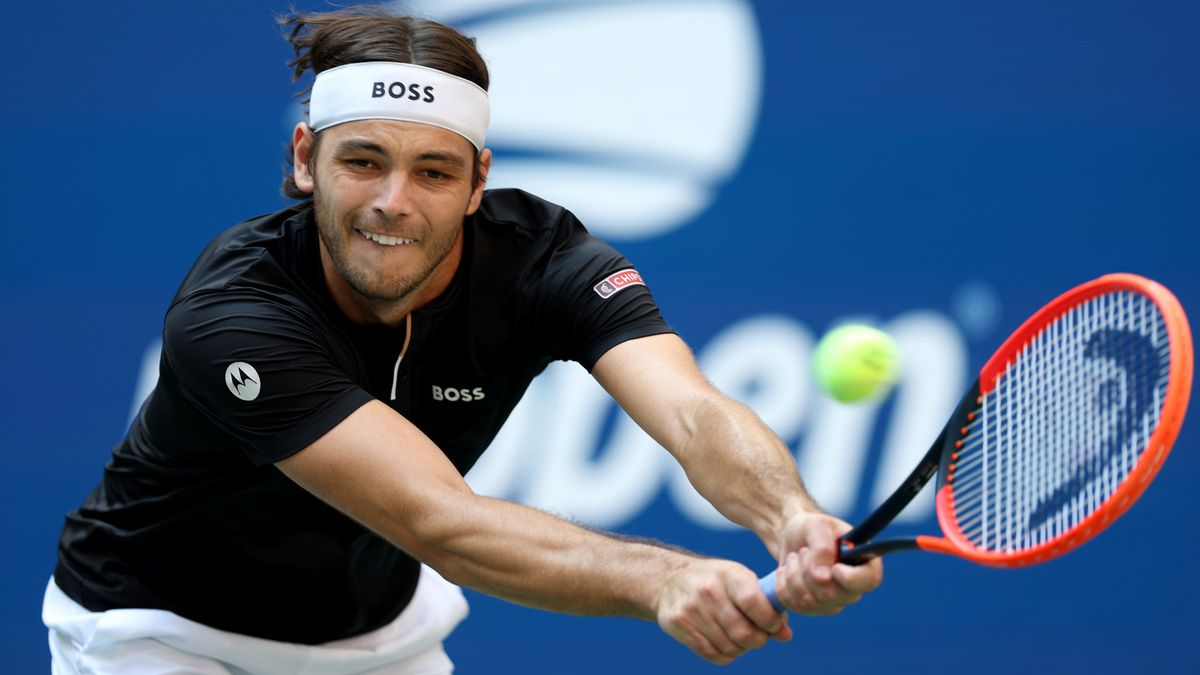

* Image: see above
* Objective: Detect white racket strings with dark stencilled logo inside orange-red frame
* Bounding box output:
[953,291,1170,552]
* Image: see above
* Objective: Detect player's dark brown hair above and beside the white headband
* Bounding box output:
[278,5,490,199]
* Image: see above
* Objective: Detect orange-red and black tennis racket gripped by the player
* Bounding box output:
[760,269,1193,611]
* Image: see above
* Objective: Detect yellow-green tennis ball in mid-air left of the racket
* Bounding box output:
[812,323,900,404]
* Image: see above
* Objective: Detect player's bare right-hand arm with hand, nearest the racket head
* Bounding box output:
[592,334,883,614]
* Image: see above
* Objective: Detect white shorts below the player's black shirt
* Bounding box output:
[42,566,467,675]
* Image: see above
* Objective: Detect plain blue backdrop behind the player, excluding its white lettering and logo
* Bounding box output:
[0,0,1200,674]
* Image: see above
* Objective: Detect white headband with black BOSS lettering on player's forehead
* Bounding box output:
[308,61,491,150]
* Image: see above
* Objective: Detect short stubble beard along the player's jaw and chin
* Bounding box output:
[312,186,458,304]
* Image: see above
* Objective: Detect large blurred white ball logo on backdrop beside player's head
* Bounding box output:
[392,0,763,241]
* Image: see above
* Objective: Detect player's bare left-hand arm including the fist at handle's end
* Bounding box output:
[276,401,791,663]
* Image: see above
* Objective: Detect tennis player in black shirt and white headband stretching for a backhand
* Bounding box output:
[43,8,882,675]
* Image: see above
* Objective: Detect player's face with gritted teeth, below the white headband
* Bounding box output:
[296,120,490,315]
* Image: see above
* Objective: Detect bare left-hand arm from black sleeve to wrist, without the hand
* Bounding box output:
[277,401,698,619]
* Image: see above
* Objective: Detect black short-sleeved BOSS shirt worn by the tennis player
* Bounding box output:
[55,190,670,644]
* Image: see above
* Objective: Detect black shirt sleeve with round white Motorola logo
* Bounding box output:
[160,283,372,465]
